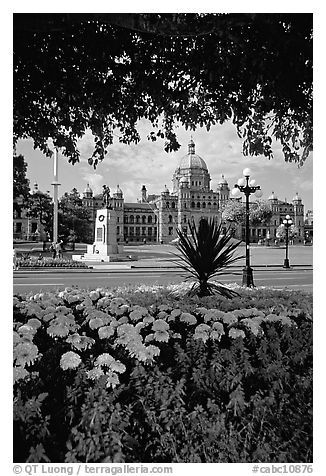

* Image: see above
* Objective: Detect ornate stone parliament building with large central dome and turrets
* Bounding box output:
[76,139,305,243]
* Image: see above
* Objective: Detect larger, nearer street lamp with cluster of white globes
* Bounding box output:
[231,168,263,287]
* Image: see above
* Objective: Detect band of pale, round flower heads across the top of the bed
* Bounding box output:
[14,288,300,388]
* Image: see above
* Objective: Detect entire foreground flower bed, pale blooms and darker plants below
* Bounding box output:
[14,288,312,463]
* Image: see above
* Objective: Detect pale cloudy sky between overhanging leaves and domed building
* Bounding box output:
[17,120,313,211]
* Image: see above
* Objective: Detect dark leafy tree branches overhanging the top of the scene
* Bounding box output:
[14,13,312,167]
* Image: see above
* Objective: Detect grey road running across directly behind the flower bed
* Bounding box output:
[13,266,313,294]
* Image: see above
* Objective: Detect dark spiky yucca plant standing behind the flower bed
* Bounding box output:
[176,218,244,298]
